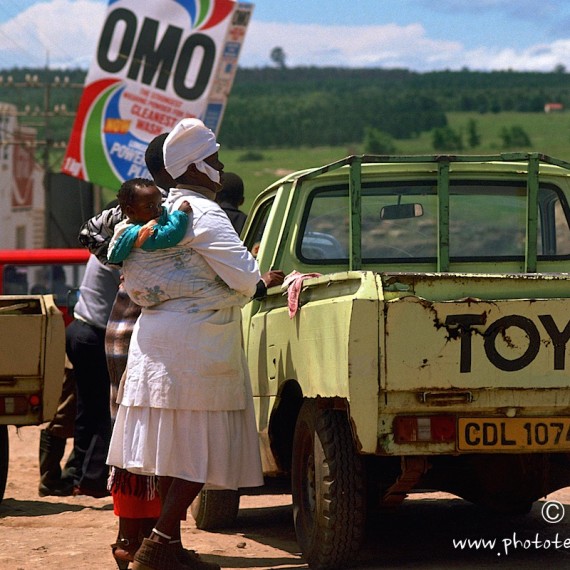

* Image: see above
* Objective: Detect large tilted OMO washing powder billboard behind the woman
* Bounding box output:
[62,0,253,188]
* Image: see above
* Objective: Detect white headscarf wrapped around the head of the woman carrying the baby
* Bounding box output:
[162,118,220,183]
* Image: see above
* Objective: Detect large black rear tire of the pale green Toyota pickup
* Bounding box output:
[291,400,366,570]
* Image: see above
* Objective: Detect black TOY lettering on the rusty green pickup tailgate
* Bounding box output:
[445,314,570,373]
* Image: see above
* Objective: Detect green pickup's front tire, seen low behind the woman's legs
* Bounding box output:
[190,489,239,530]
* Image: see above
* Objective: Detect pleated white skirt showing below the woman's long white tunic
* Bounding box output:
[107,372,263,489]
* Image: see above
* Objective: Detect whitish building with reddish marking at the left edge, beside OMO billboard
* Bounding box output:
[0,103,45,249]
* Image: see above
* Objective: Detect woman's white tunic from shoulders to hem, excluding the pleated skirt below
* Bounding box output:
[121,185,260,411]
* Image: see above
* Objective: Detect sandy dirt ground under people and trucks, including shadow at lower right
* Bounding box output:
[0,427,570,570]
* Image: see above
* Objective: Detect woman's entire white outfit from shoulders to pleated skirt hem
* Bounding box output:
[107,188,263,489]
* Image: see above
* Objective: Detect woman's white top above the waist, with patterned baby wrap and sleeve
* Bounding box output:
[123,188,261,311]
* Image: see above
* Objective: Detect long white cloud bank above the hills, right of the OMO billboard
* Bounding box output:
[240,21,570,71]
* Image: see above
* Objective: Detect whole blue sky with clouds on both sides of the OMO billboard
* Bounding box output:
[0,0,570,71]
